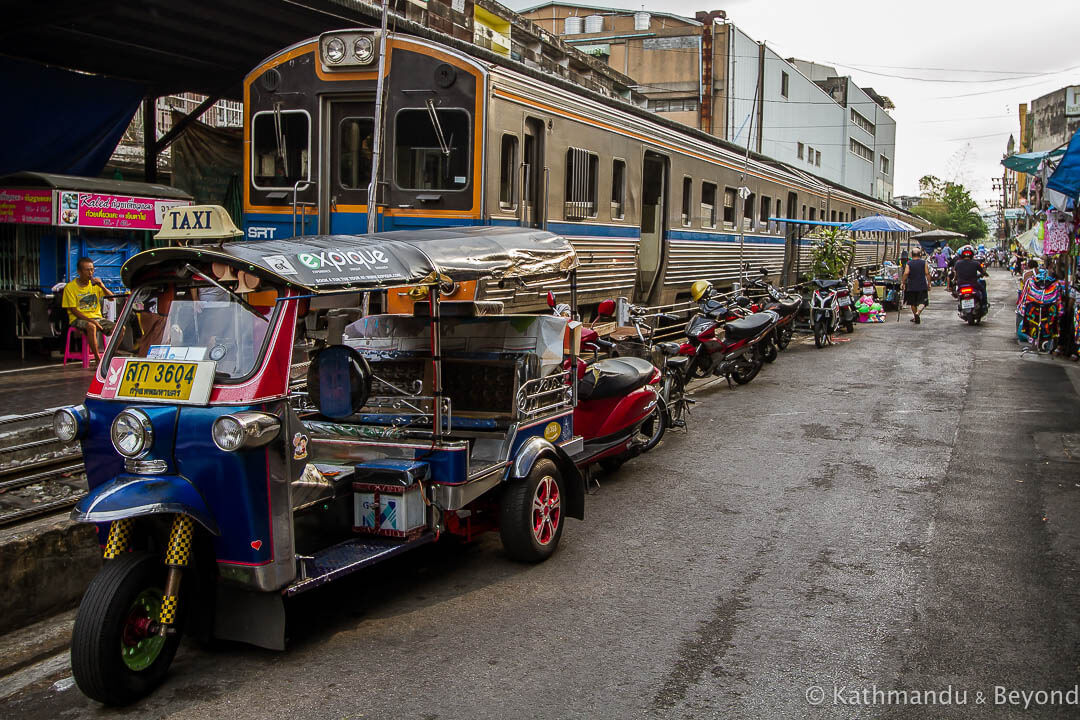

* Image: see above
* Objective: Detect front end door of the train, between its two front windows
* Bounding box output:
[319,98,375,233]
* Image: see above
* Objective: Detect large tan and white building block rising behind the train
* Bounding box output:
[522,2,896,202]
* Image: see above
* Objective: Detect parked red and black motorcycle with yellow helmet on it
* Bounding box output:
[679,281,780,385]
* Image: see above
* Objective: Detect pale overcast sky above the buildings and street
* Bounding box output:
[503,0,1080,207]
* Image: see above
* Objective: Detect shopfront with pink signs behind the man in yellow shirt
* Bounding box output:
[0,173,192,360]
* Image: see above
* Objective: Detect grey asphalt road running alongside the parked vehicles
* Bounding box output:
[0,271,1080,719]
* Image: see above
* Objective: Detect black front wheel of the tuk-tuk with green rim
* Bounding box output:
[71,553,183,705]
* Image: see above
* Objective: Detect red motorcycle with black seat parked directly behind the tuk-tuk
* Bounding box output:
[548,293,664,472]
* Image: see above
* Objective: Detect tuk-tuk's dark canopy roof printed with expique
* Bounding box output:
[122,227,578,293]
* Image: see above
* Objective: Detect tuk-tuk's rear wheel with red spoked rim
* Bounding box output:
[499,459,563,562]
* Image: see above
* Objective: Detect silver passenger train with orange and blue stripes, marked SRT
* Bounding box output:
[243,28,929,309]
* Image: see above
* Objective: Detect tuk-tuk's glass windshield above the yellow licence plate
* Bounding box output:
[104,279,279,382]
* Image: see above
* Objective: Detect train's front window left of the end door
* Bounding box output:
[252,110,311,190]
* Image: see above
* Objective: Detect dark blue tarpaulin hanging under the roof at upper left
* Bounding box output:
[0,56,146,177]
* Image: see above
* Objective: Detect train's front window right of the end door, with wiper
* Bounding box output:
[394,108,470,190]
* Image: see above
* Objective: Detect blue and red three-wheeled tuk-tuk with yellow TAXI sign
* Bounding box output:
[54,206,585,704]
